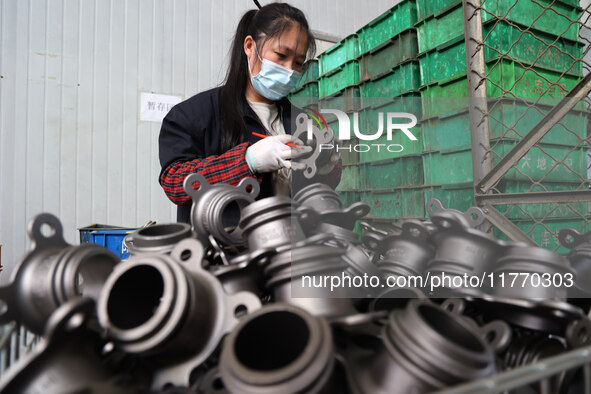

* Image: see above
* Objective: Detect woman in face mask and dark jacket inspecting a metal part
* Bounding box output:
[159,3,340,225]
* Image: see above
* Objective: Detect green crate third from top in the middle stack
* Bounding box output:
[360,60,421,98]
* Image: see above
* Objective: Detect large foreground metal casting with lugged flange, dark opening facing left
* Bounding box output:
[98,239,261,389]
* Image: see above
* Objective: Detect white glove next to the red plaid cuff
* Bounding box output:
[246,134,292,173]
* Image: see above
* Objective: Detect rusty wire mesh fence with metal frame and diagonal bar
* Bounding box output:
[464,0,591,250]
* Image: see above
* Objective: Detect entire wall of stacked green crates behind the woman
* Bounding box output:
[291,0,588,248]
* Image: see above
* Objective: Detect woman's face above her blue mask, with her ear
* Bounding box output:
[244,25,308,76]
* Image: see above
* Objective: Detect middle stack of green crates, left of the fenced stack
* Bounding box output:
[336,0,422,203]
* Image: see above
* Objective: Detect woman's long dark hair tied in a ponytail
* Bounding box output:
[220,3,316,151]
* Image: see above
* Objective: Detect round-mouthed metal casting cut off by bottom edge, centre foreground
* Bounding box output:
[220,304,335,394]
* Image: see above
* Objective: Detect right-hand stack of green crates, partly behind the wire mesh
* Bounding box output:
[416,0,587,243]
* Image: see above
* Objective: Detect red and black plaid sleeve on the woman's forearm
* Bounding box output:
[160,142,262,205]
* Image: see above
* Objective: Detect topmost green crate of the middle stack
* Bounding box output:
[357,0,417,53]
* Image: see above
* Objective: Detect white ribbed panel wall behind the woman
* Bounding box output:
[0,0,397,283]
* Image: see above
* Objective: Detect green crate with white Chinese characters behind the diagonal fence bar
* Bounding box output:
[424,140,587,185]
